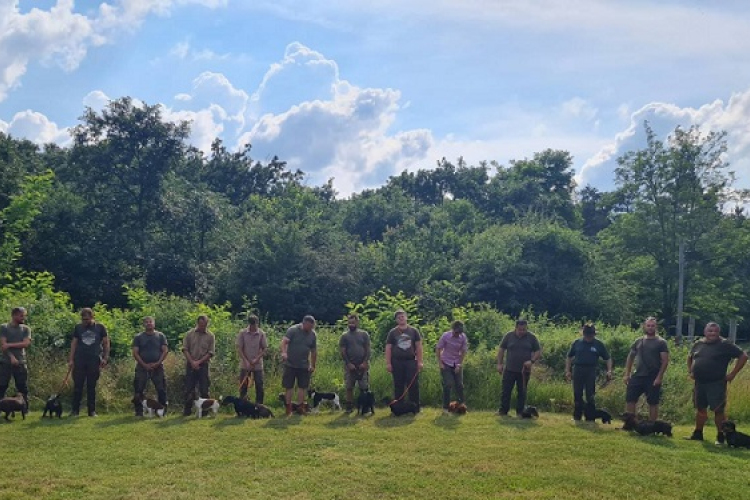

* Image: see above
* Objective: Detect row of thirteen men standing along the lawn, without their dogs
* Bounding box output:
[0,307,748,441]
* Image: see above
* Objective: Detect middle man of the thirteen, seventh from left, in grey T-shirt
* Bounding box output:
[339,314,371,413]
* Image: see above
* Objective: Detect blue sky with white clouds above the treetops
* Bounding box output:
[0,0,750,196]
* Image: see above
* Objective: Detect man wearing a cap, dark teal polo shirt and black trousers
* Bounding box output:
[565,325,612,422]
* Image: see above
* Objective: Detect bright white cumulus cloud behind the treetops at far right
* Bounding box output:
[577,89,750,190]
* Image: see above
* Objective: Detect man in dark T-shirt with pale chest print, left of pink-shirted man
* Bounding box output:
[385,309,424,411]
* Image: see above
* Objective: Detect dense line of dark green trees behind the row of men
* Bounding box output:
[0,97,750,333]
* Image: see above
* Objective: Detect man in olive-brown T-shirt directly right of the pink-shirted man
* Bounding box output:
[497,319,542,417]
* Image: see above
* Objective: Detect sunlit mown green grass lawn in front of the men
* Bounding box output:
[0,409,750,500]
